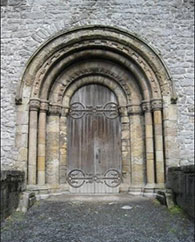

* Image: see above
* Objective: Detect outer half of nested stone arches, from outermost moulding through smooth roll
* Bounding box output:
[17,26,175,104]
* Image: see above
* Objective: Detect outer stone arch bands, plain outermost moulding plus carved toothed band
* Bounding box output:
[18,26,175,103]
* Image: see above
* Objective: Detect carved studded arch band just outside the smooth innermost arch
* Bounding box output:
[49,61,143,105]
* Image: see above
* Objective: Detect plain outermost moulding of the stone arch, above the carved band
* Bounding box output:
[16,25,177,105]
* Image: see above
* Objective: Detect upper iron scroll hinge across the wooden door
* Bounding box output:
[69,102,119,119]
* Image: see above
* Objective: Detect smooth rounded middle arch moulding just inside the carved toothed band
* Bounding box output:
[32,45,162,99]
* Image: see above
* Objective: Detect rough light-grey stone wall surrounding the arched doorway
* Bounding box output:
[1,0,194,169]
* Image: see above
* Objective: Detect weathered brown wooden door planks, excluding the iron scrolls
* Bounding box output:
[68,84,121,193]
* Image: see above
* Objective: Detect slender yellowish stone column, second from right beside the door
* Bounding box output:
[142,101,155,188]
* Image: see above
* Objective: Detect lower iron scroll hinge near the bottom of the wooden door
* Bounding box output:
[67,169,122,188]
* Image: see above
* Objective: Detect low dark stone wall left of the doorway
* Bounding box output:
[1,171,24,220]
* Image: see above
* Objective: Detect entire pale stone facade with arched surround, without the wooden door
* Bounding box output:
[1,0,194,193]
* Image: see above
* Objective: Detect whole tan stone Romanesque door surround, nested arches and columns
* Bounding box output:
[16,26,176,194]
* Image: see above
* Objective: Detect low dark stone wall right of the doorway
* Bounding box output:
[167,165,195,217]
